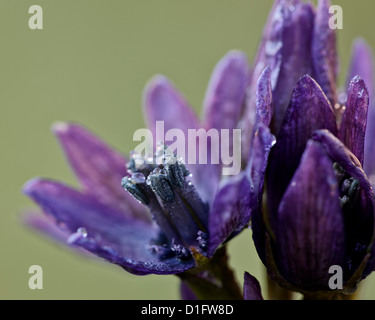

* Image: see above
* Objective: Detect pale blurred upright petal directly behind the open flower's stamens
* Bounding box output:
[143,76,221,202]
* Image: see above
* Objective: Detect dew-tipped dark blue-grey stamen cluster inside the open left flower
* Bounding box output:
[121,145,208,260]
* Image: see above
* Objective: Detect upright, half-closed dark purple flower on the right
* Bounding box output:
[251,0,375,293]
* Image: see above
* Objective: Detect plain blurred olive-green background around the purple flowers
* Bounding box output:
[0,0,375,299]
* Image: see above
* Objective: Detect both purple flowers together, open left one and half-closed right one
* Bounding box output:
[24,0,375,300]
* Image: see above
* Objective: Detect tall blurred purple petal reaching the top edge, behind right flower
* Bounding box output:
[248,0,314,133]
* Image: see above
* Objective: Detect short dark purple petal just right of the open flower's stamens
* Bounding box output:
[208,173,250,256]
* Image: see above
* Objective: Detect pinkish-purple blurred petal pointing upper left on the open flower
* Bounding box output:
[52,123,148,219]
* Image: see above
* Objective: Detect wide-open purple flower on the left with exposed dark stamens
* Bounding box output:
[24,51,269,298]
